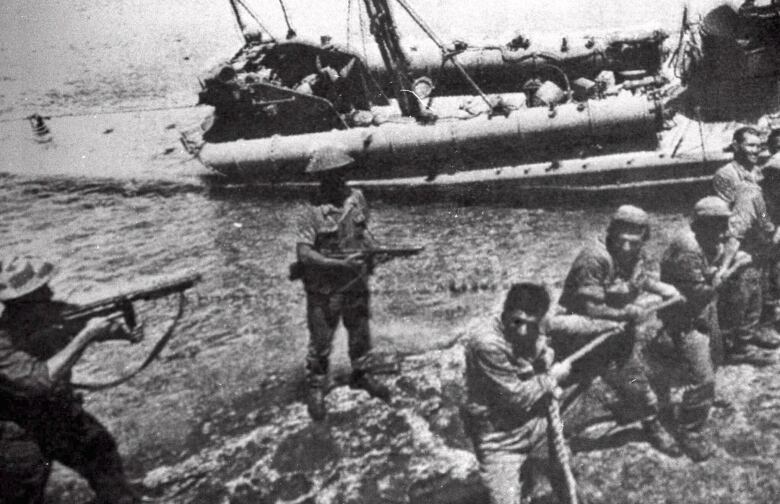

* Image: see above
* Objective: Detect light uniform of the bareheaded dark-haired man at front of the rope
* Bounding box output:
[463,319,564,504]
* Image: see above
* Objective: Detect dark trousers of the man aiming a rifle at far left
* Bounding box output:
[0,400,138,504]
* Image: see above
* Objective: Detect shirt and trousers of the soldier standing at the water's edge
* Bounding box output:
[298,189,375,394]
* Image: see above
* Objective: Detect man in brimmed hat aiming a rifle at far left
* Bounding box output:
[0,257,139,504]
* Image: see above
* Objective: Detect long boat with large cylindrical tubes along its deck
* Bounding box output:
[184,0,780,203]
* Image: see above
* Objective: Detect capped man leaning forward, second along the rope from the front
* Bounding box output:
[547,205,679,455]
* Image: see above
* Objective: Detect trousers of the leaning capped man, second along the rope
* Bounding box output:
[546,314,658,421]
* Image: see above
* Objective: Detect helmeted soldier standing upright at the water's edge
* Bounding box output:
[296,157,390,420]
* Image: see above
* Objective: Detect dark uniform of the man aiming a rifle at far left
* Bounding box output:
[0,263,138,504]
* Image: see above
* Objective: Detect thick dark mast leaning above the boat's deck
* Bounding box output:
[364,0,420,117]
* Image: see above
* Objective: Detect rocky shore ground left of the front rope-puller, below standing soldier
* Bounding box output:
[144,345,484,504]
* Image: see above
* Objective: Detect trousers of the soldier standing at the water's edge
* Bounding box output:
[306,290,371,386]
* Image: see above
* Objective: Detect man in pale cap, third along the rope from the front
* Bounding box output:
[659,196,736,462]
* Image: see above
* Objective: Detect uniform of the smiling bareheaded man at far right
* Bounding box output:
[718,183,780,350]
